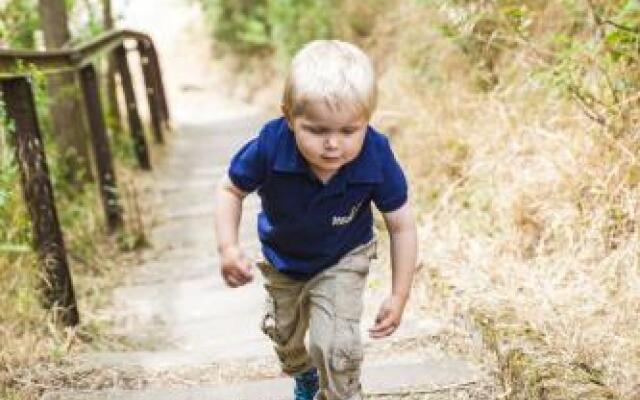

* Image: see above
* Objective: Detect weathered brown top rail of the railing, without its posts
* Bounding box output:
[0,29,153,78]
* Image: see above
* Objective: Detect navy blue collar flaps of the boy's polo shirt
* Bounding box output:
[273,120,383,183]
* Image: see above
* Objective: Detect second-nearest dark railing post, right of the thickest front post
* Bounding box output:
[80,64,123,233]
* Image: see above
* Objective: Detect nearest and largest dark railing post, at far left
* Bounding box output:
[0,77,80,326]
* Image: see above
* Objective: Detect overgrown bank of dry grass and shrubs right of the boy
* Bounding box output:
[198,0,640,399]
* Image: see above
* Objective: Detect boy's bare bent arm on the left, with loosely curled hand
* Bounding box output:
[214,176,253,287]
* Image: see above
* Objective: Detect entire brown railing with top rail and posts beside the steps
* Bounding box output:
[0,30,170,325]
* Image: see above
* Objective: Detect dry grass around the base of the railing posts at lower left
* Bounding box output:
[0,158,153,400]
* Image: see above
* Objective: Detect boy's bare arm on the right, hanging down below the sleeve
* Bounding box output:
[369,202,418,338]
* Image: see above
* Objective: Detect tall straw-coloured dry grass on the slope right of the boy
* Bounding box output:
[373,3,640,399]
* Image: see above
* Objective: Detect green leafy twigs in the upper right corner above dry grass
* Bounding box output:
[432,0,640,133]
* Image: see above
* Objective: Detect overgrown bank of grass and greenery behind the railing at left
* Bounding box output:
[0,0,151,399]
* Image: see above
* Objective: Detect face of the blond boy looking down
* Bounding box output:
[289,104,369,181]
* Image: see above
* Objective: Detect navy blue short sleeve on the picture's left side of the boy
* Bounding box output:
[228,136,266,192]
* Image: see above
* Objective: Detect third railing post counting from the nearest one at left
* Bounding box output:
[114,44,151,170]
